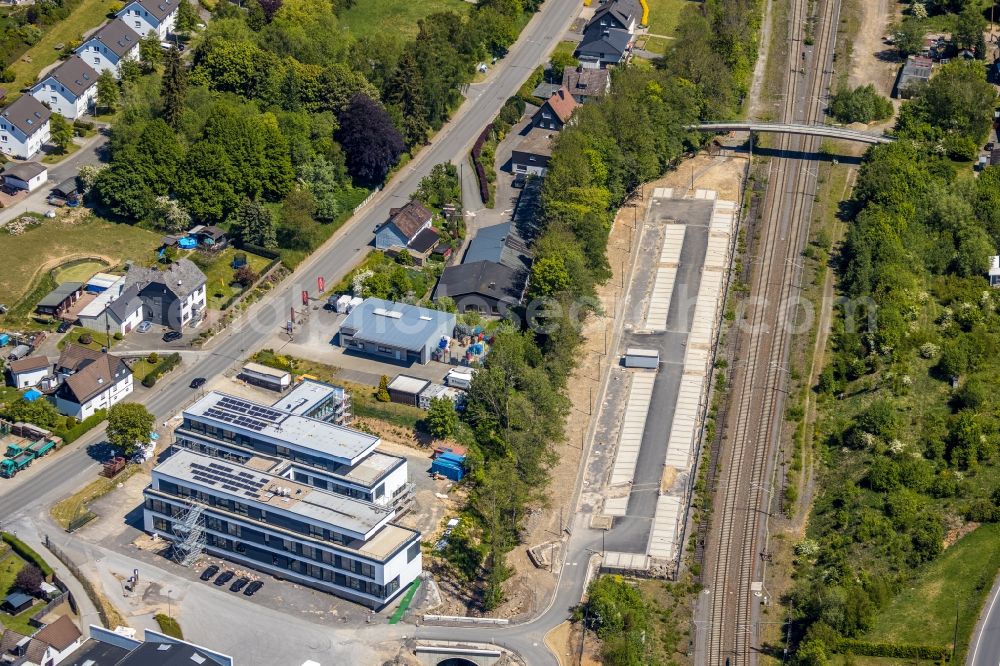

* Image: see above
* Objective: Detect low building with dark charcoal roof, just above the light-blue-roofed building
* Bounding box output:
[434,261,528,316]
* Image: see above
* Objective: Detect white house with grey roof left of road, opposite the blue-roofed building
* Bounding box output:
[125,259,207,331]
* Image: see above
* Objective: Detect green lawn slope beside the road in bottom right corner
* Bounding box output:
[865,523,1000,663]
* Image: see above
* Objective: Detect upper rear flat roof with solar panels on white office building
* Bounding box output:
[184,391,380,464]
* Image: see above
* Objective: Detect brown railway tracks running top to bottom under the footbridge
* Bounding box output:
[697,0,840,666]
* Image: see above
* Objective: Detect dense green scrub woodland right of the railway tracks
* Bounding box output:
[788,55,1000,666]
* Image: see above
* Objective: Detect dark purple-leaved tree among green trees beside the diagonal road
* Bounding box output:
[338,94,406,184]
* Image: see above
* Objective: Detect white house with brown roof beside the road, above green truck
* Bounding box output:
[55,343,133,421]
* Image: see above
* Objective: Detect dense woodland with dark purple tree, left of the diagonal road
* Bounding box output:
[93,0,538,263]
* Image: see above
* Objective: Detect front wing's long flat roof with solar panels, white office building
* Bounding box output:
[153,449,394,537]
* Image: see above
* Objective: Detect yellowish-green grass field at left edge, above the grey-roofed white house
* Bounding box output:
[0,214,162,321]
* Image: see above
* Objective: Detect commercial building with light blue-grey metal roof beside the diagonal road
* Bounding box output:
[338,298,455,363]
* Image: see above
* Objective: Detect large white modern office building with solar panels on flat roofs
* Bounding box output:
[143,387,422,608]
